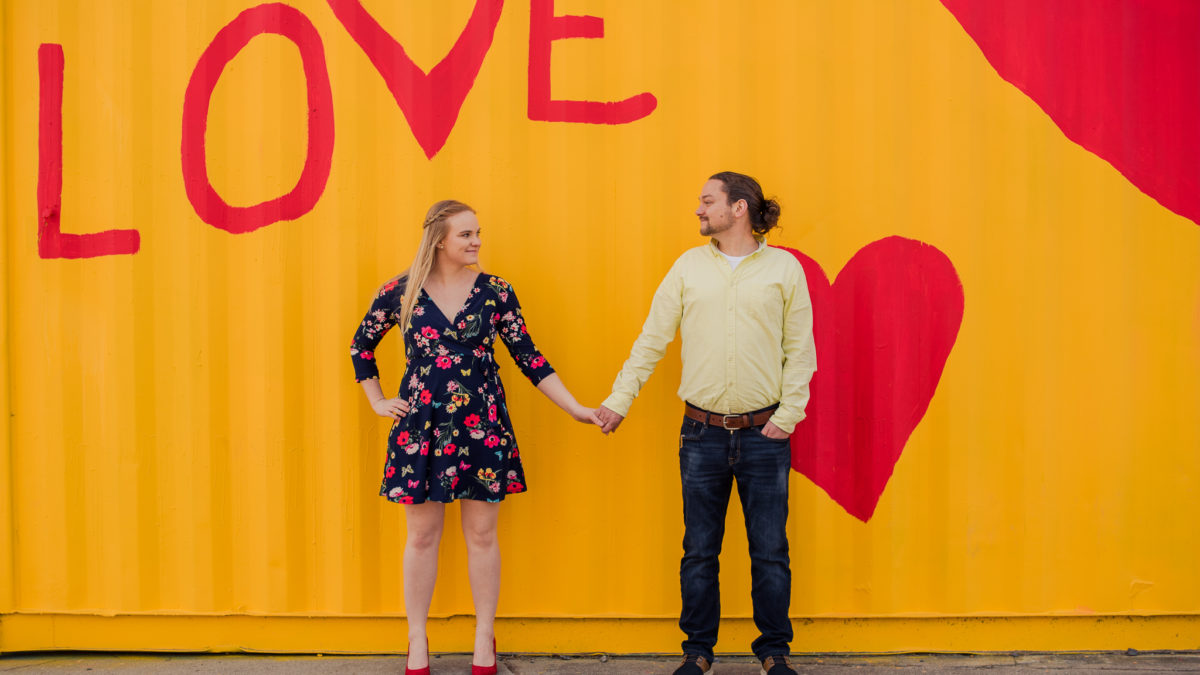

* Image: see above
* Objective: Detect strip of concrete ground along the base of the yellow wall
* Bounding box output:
[0,652,1200,675]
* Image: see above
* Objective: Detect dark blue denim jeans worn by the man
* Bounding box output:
[679,418,792,663]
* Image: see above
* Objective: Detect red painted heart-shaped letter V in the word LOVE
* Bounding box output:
[328,0,504,159]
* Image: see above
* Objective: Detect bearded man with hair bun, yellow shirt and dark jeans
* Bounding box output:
[598,172,816,675]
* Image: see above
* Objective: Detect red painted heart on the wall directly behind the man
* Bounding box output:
[785,237,964,522]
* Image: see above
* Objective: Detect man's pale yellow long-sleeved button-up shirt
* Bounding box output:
[604,240,817,434]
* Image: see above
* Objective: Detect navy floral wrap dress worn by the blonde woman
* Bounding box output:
[350,274,554,504]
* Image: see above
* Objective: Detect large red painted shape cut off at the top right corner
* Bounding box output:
[942,0,1200,225]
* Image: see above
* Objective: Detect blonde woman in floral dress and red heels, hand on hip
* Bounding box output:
[350,201,599,675]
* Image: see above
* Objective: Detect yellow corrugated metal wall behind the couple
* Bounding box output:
[0,0,1200,652]
